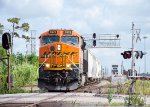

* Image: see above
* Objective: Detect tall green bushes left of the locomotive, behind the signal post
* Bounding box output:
[0,48,38,94]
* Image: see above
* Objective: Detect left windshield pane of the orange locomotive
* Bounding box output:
[42,36,59,45]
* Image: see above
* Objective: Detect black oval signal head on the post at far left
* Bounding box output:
[2,32,11,50]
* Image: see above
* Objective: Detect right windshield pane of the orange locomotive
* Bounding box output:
[61,36,79,46]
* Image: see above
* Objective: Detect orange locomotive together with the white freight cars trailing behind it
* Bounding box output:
[38,29,101,91]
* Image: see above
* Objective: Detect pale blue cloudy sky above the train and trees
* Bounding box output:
[0,0,150,73]
